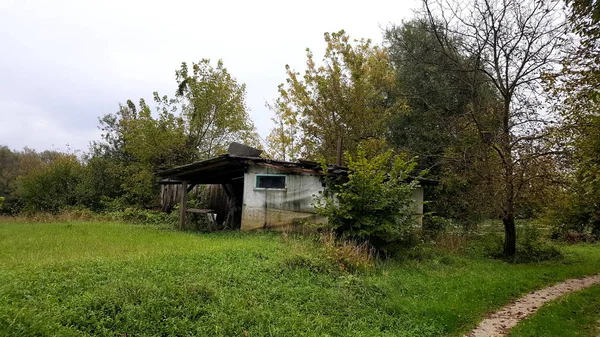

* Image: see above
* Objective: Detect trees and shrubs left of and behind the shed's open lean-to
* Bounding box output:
[0,59,258,214]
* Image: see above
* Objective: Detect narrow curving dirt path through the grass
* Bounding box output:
[467,274,600,337]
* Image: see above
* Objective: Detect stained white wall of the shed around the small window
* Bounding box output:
[241,166,324,230]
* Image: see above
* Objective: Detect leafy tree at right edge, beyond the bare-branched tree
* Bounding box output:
[547,0,600,237]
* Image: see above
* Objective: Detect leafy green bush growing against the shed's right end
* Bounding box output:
[316,148,418,254]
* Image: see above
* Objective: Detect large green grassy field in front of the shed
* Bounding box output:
[0,222,600,336]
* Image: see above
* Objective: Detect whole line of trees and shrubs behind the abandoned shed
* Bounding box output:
[0,0,600,255]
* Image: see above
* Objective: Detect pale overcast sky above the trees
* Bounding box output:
[0,0,418,151]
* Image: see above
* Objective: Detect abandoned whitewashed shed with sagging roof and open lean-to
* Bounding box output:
[158,143,423,231]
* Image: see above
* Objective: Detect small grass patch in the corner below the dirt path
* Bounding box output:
[510,285,600,337]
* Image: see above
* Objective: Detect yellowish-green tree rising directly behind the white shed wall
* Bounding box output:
[268,31,401,162]
